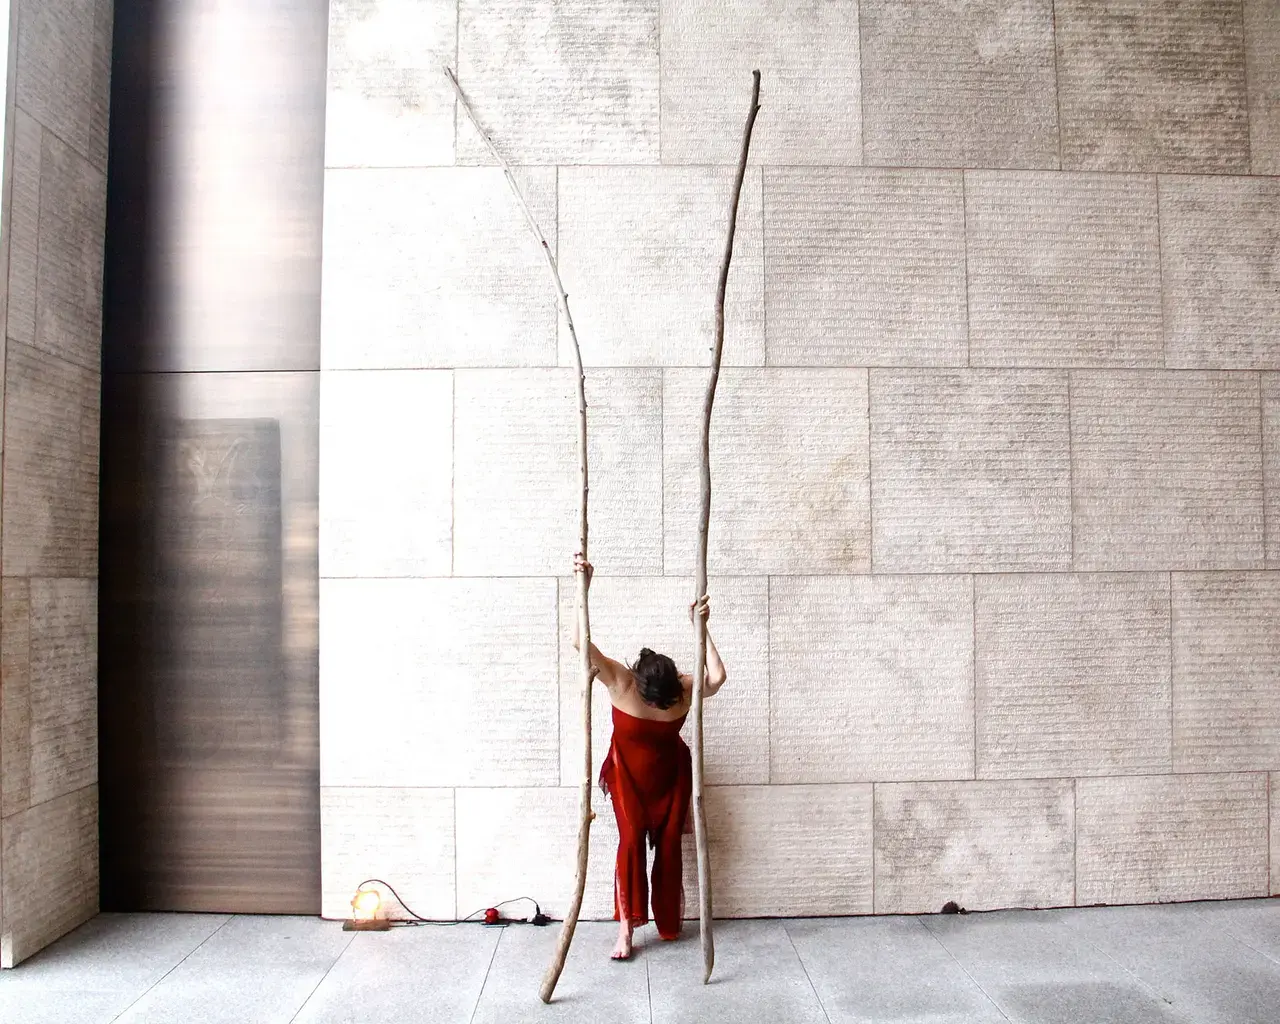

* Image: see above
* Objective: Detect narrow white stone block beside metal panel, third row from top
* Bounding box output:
[320,370,453,576]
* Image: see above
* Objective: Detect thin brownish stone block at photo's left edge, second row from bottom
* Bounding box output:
[0,577,31,819]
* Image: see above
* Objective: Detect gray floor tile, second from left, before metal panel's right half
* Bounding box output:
[112,916,352,1024]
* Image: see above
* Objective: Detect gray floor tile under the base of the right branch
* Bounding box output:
[644,920,827,1024]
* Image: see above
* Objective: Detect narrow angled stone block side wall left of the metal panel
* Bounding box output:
[0,0,113,968]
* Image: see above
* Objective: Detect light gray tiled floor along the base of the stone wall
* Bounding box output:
[0,899,1280,1024]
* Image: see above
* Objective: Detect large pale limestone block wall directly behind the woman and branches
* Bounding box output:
[320,0,1280,918]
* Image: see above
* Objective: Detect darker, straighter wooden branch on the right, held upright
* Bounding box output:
[692,72,760,984]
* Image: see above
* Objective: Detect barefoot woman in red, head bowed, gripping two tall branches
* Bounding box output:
[573,554,726,960]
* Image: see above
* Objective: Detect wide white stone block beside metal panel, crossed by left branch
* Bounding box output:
[320,168,558,370]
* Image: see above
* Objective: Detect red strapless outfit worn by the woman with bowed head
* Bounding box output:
[600,708,694,938]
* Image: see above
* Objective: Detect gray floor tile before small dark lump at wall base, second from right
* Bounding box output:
[922,910,1189,1024]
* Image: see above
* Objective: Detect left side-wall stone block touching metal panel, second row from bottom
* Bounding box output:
[29,580,97,804]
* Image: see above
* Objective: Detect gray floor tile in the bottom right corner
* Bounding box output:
[1062,904,1280,1024]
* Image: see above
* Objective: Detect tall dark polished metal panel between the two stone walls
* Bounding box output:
[100,0,326,913]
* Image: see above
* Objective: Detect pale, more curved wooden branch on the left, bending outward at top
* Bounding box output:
[444,68,595,1002]
